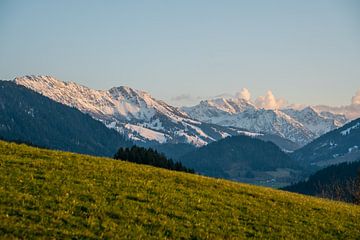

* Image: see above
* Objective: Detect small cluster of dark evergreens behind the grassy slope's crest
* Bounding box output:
[114,146,194,173]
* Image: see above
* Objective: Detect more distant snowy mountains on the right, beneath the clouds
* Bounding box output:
[182,98,347,145]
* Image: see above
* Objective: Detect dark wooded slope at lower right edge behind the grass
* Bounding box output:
[284,160,360,204]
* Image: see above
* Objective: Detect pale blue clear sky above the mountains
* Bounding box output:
[0,0,360,105]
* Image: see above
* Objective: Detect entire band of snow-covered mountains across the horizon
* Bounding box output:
[14,76,347,151]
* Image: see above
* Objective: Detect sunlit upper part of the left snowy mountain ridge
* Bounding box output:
[15,76,180,120]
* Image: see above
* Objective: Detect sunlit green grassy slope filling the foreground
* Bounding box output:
[0,142,360,239]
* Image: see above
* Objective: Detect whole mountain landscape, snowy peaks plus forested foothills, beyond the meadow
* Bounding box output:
[0,76,360,189]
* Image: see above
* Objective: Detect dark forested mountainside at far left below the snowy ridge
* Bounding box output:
[0,81,132,156]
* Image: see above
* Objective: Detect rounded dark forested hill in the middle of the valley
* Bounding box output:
[179,136,302,187]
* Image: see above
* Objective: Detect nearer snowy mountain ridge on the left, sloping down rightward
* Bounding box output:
[14,76,298,151]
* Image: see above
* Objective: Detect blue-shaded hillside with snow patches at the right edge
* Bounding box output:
[291,118,360,167]
